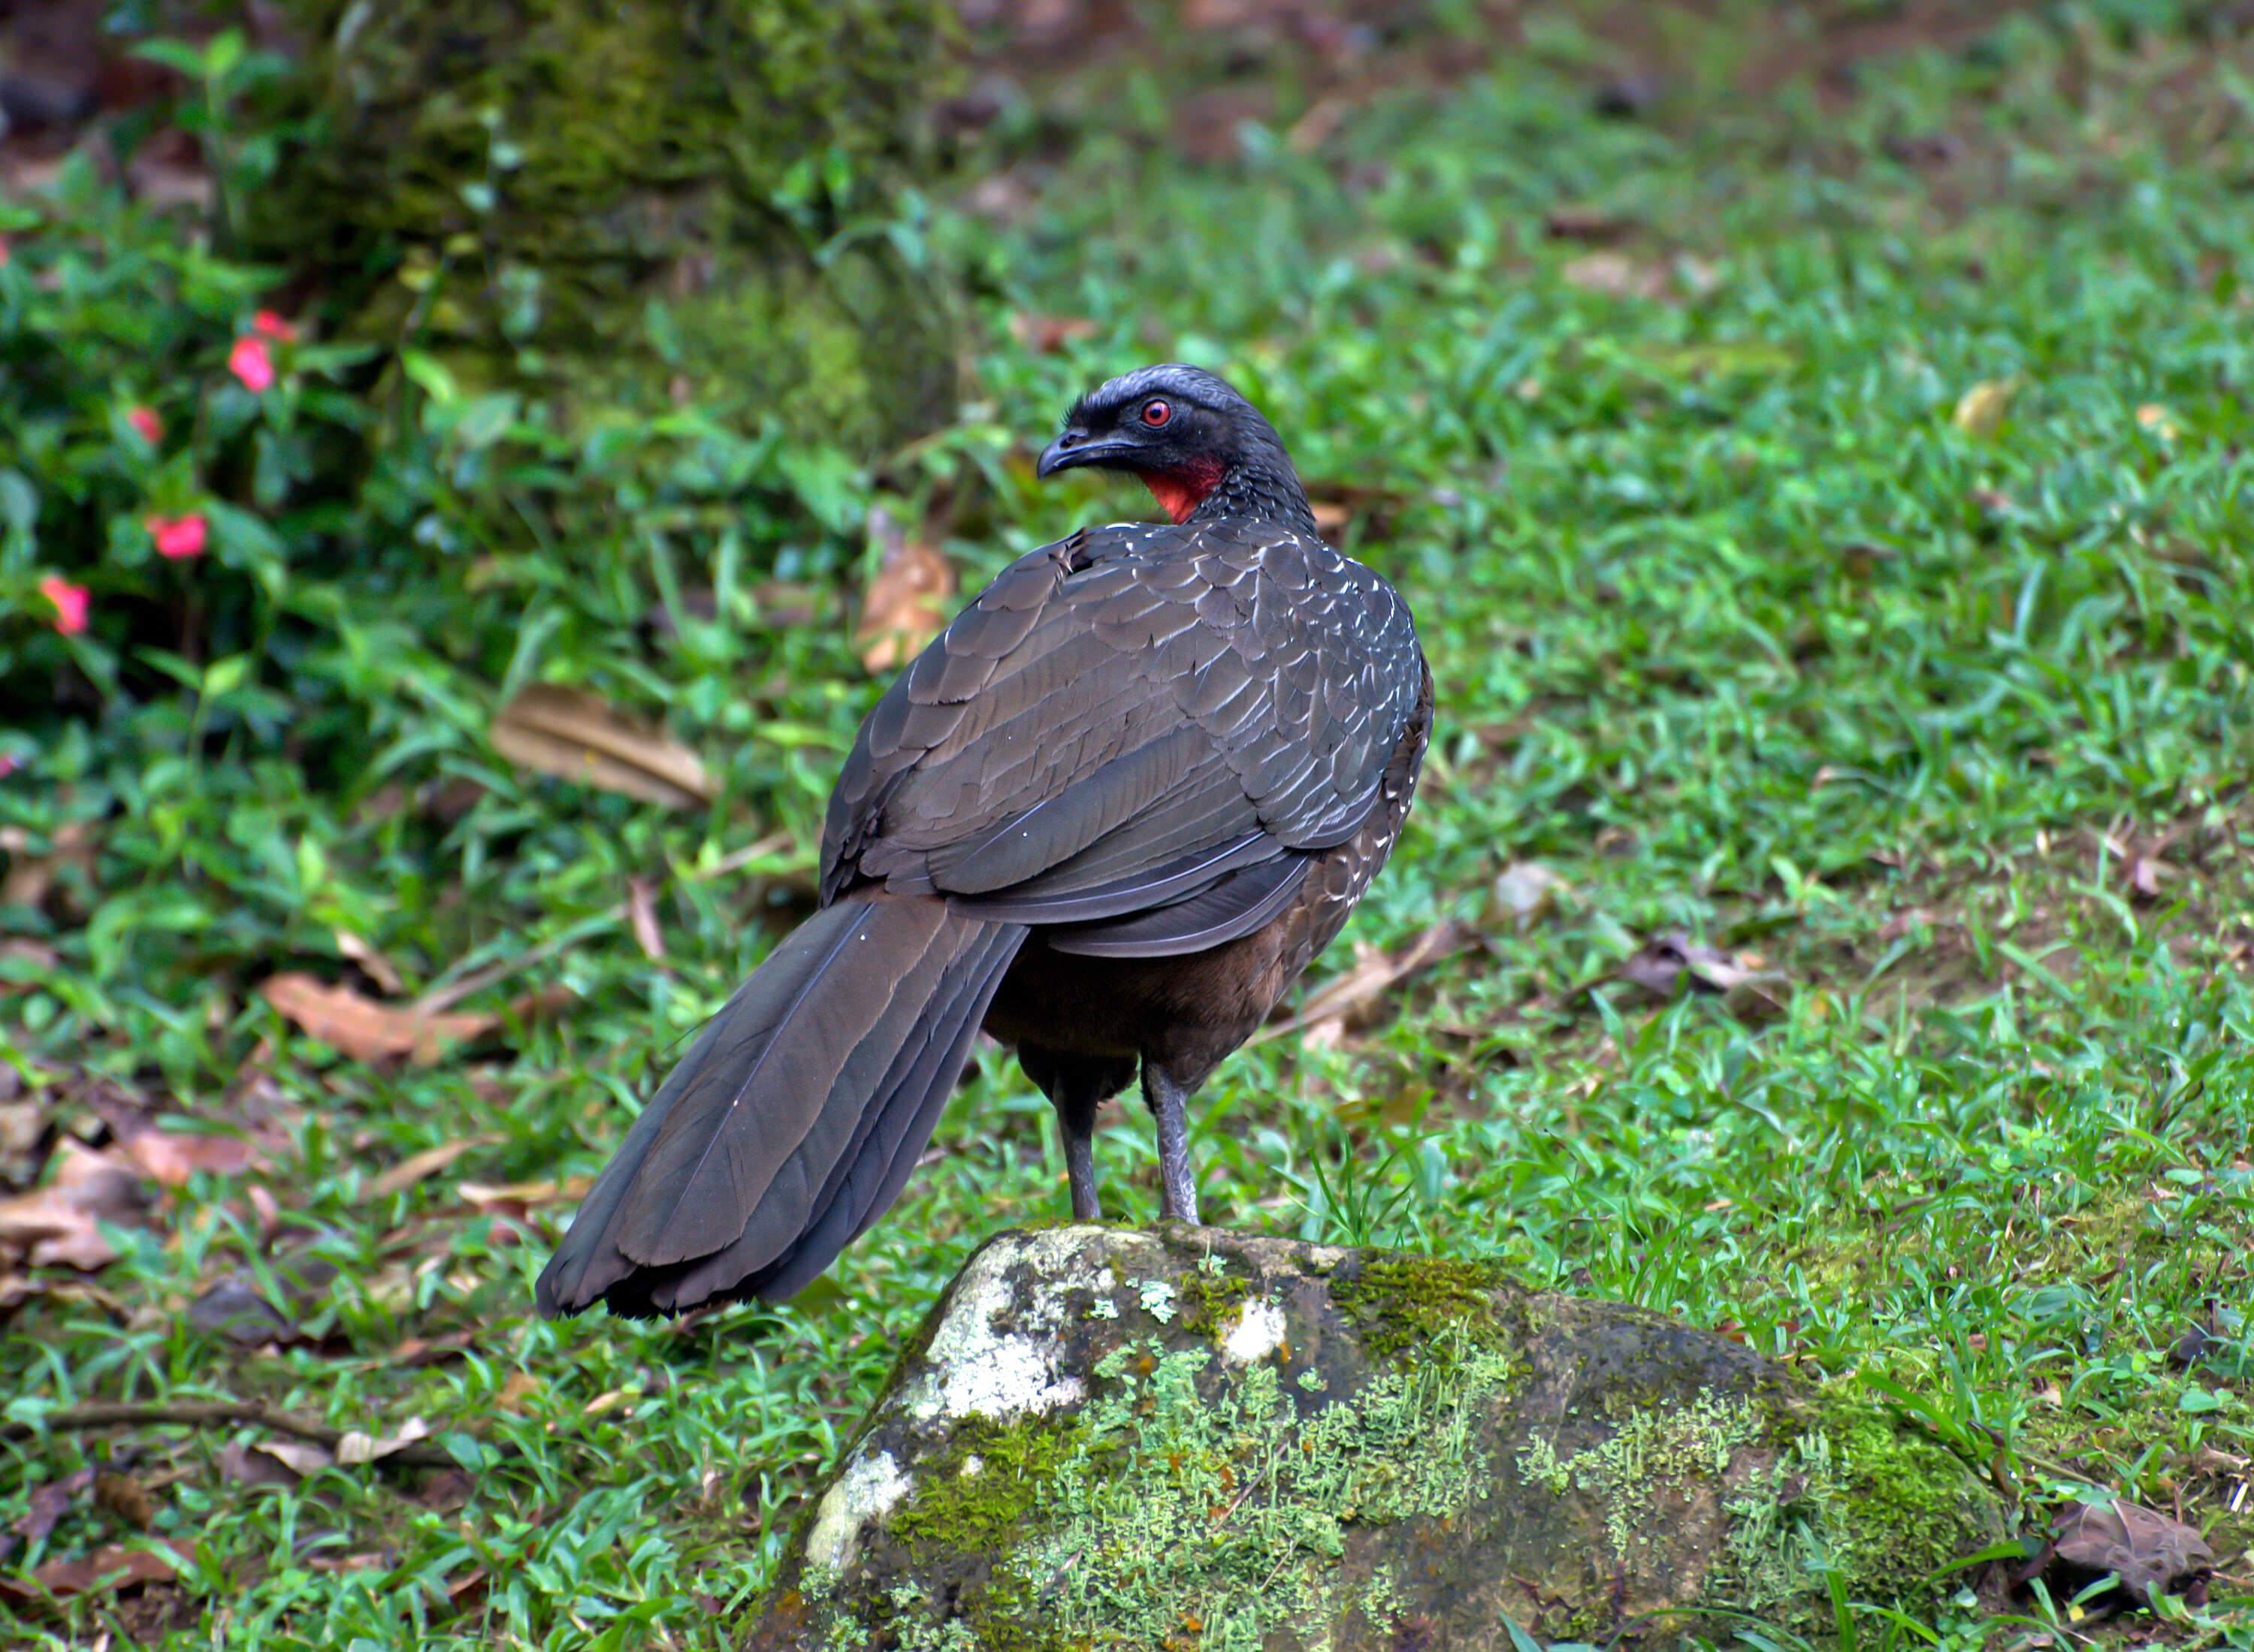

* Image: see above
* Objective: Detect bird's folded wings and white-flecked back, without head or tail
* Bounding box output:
[823,523,1420,929]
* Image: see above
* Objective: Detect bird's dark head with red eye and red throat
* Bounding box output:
[1035,363,1314,534]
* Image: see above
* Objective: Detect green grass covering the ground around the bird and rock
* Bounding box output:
[0,5,2254,1647]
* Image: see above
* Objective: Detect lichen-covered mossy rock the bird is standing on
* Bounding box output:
[751,1226,2002,1652]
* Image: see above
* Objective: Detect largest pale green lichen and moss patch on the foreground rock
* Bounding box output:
[811,1330,1512,1652]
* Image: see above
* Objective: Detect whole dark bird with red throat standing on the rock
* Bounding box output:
[534,363,1434,1316]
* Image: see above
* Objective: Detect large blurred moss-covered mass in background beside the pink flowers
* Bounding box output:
[248,0,958,451]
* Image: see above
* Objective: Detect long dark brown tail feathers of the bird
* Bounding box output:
[536,897,1026,1314]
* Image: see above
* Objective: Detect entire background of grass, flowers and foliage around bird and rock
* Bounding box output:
[0,0,2254,1647]
